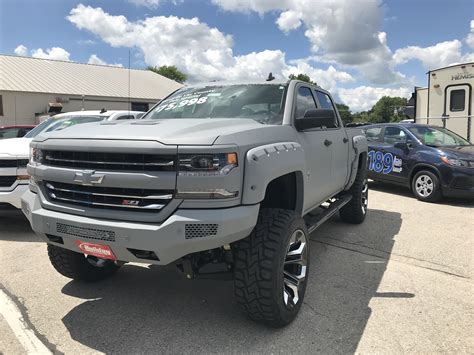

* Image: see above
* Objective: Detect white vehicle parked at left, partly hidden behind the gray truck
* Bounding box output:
[0,111,143,208]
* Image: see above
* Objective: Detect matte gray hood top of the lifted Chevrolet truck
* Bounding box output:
[34,118,263,145]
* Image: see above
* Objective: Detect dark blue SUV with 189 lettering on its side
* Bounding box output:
[362,123,474,202]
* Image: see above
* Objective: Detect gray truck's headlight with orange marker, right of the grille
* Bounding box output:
[178,153,238,176]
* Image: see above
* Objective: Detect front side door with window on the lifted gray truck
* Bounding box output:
[293,84,332,211]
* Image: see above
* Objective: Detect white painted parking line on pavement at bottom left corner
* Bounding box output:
[0,289,52,354]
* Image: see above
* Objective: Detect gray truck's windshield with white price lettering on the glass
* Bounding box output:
[143,84,286,125]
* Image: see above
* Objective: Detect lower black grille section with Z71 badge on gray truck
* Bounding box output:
[43,181,173,212]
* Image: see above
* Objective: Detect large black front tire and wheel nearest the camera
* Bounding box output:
[234,208,309,327]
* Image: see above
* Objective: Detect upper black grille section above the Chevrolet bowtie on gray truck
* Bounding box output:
[43,150,176,171]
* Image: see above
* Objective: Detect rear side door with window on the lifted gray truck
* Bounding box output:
[315,90,350,194]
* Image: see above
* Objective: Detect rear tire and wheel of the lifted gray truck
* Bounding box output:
[339,166,369,224]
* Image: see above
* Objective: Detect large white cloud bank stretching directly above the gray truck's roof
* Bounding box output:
[67,4,352,87]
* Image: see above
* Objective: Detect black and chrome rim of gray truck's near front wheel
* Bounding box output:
[283,229,308,308]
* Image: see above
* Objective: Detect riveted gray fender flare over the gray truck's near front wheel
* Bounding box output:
[242,142,306,209]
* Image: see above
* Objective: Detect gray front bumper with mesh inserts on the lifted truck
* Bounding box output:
[22,191,259,265]
